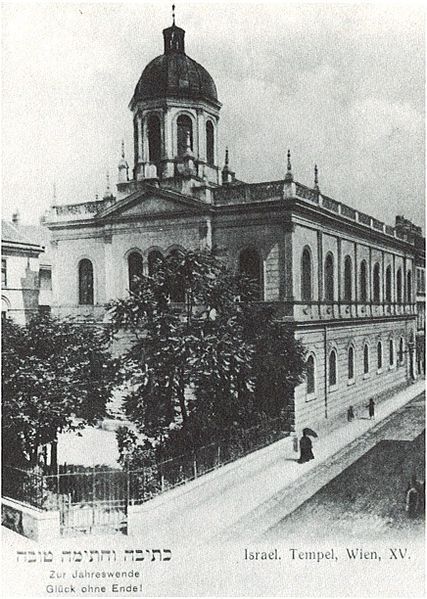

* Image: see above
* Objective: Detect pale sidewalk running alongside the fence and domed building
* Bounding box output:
[130,380,425,545]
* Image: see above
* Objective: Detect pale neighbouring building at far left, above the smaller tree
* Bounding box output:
[1,213,52,324]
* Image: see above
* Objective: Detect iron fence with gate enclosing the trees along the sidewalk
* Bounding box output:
[2,419,288,534]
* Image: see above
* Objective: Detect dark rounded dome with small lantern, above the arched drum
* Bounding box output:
[131,25,219,105]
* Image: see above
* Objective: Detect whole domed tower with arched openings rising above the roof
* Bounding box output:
[129,7,221,184]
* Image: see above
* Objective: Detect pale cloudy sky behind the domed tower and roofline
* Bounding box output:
[2,0,425,225]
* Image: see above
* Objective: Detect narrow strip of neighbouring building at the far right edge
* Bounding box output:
[396,216,426,374]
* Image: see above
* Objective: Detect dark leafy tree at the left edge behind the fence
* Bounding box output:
[2,315,118,465]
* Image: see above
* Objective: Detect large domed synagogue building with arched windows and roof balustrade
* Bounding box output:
[48,16,416,430]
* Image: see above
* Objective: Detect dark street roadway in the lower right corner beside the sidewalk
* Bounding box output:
[259,394,425,541]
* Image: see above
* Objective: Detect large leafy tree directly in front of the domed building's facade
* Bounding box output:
[109,250,304,464]
